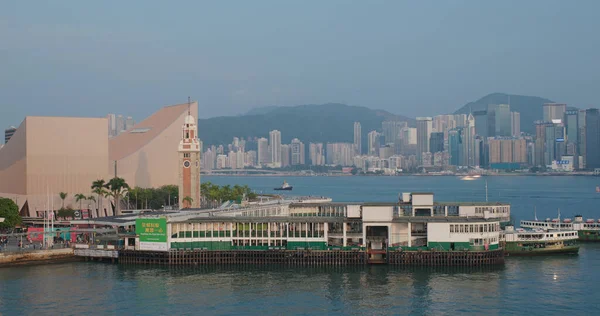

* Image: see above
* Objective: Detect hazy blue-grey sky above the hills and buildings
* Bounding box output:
[0,0,600,128]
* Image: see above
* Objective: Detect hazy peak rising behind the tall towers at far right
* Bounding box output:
[454,93,553,134]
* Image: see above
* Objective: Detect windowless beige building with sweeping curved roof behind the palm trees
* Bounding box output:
[0,102,198,217]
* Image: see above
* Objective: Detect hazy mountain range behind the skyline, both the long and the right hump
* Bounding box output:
[198,93,564,147]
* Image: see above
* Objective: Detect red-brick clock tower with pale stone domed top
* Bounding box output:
[179,100,200,209]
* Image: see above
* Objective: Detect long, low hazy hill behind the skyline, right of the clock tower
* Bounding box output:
[198,103,415,151]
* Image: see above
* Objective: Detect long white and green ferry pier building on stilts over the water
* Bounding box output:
[118,193,510,265]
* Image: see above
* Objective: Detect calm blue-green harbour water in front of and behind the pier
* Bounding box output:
[0,177,600,315]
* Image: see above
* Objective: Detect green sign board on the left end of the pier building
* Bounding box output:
[135,218,169,251]
